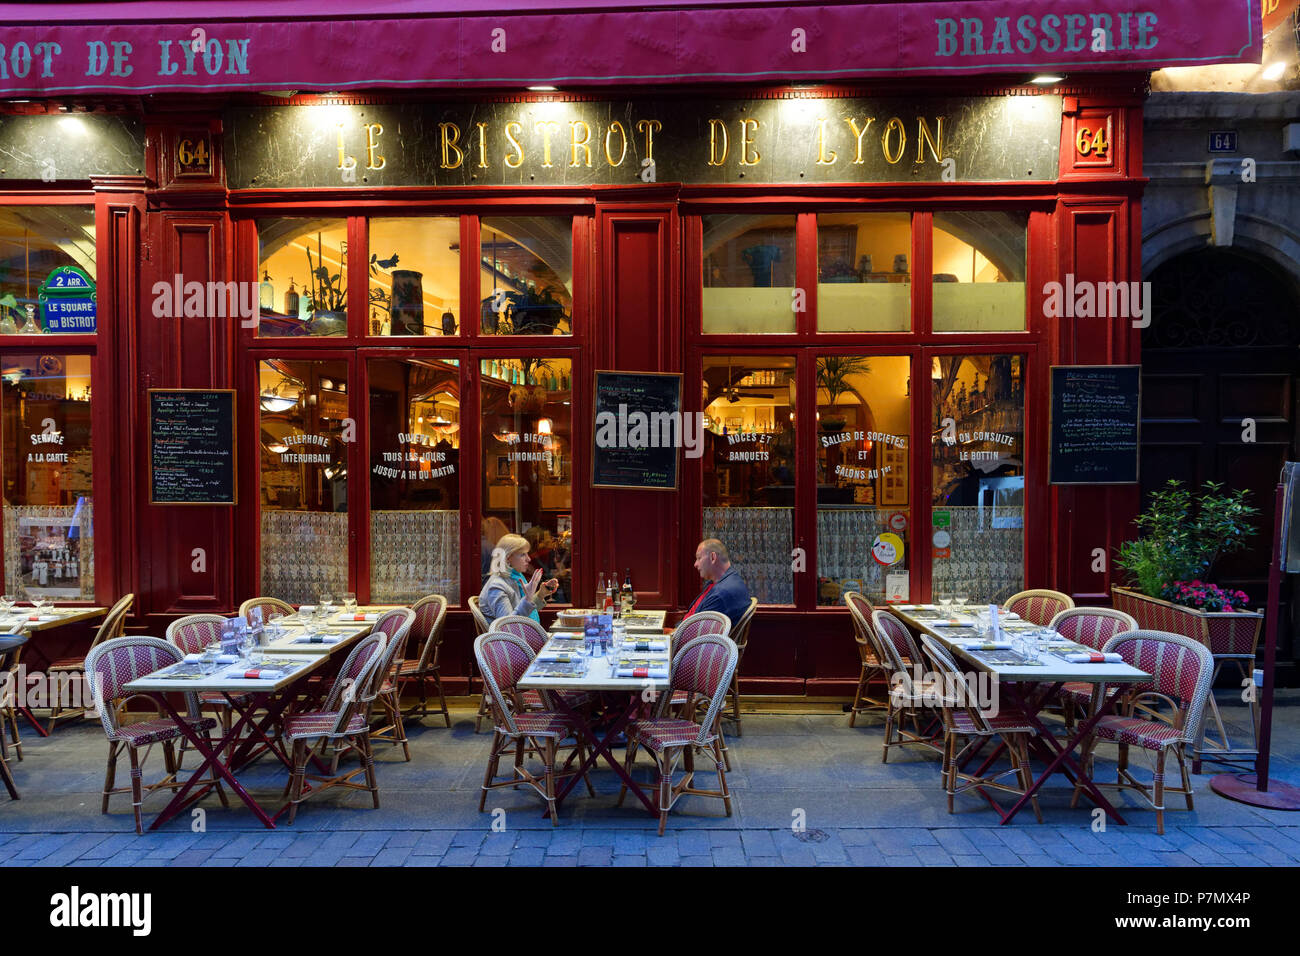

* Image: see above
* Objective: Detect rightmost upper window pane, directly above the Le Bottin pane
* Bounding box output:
[933,211,1030,332]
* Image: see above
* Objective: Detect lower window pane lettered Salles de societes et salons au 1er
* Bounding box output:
[816,355,913,605]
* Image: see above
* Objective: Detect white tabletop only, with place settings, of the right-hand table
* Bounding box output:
[888,605,1151,684]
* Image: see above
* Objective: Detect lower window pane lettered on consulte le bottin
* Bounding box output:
[930,355,1024,604]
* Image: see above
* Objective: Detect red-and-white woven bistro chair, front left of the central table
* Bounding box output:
[475,631,595,826]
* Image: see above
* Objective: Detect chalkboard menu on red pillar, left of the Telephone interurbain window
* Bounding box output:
[150,389,235,505]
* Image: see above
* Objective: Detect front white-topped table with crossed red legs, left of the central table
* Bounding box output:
[126,653,330,830]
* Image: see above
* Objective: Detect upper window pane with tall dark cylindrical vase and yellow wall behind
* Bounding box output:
[367,216,460,336]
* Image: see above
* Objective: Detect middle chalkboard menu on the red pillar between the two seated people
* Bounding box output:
[592,372,683,490]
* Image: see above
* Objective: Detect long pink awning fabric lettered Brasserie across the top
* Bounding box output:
[0,0,1262,96]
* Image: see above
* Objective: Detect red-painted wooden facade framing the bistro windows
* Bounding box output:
[0,74,1144,697]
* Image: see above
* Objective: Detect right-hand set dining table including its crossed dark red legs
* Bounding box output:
[887,605,1152,825]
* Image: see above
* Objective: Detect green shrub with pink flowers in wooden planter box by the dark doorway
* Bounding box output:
[1110,480,1264,654]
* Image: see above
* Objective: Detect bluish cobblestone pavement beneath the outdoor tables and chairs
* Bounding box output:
[0,692,1300,866]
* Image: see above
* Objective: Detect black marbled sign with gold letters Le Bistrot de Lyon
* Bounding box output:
[224,94,1062,189]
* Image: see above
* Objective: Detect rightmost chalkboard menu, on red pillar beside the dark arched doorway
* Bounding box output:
[1050,365,1141,485]
